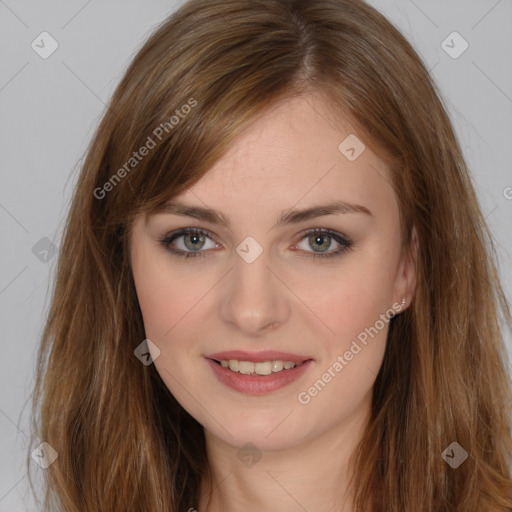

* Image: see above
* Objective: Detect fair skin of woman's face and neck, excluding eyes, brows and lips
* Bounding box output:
[130,96,415,512]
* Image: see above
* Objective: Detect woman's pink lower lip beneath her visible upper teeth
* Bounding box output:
[207,359,313,395]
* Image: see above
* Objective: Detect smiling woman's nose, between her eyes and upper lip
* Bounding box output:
[220,251,290,337]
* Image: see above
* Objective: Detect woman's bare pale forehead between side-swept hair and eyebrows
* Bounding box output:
[178,96,396,216]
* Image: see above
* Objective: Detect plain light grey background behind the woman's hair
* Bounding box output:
[0,0,512,512]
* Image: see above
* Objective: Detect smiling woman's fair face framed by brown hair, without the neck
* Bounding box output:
[131,97,414,450]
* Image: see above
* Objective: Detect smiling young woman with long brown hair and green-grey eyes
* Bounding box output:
[28,0,512,512]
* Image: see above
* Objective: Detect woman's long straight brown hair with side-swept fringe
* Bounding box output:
[28,0,512,512]
